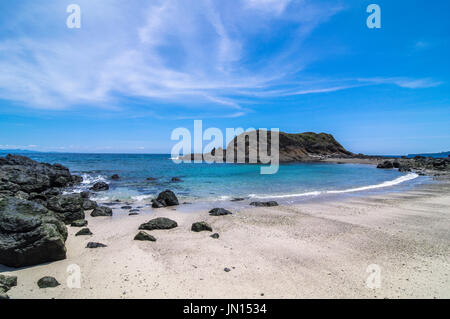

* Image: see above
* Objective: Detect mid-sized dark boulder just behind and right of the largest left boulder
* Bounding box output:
[47,194,84,224]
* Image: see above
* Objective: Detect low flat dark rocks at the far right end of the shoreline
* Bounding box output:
[377,156,450,176]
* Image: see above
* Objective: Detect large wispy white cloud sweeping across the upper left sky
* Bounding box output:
[0,0,439,117]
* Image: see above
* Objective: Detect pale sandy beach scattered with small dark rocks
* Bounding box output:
[0,180,450,298]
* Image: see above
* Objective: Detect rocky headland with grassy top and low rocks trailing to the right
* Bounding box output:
[182,130,450,176]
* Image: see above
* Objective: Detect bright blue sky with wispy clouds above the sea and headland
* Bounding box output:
[0,0,450,154]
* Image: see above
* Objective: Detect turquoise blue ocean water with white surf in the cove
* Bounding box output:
[0,153,428,205]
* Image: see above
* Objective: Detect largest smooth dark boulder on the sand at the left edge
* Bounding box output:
[0,197,67,267]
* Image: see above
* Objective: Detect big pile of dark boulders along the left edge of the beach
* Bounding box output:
[0,155,104,267]
